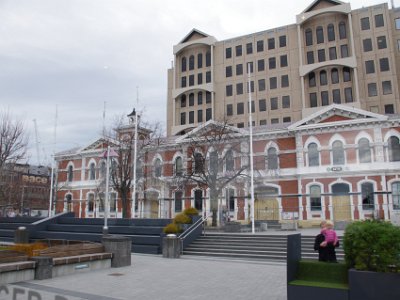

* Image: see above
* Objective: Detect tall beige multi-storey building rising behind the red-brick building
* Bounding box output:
[167,0,400,135]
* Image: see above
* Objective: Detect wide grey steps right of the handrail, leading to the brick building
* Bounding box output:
[183,233,343,262]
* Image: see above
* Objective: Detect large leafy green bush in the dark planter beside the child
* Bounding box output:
[343,220,400,272]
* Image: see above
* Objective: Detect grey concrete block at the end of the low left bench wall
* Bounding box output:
[101,235,132,268]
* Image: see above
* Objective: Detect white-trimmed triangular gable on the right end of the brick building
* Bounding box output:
[288,104,388,130]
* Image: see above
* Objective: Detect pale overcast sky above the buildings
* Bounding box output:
[0,0,388,163]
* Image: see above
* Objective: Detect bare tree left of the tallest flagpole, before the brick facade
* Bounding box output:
[176,121,249,226]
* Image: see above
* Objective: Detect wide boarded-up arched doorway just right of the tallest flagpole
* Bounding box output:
[254,186,279,221]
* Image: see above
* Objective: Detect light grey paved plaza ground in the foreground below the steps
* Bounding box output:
[4,254,286,300]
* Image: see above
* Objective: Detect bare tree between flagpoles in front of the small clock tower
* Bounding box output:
[109,112,162,218]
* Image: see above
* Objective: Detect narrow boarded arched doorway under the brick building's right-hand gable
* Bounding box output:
[332,183,351,221]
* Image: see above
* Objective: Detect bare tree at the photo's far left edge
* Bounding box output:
[0,111,28,211]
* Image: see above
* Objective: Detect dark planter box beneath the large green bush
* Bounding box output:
[349,269,400,300]
